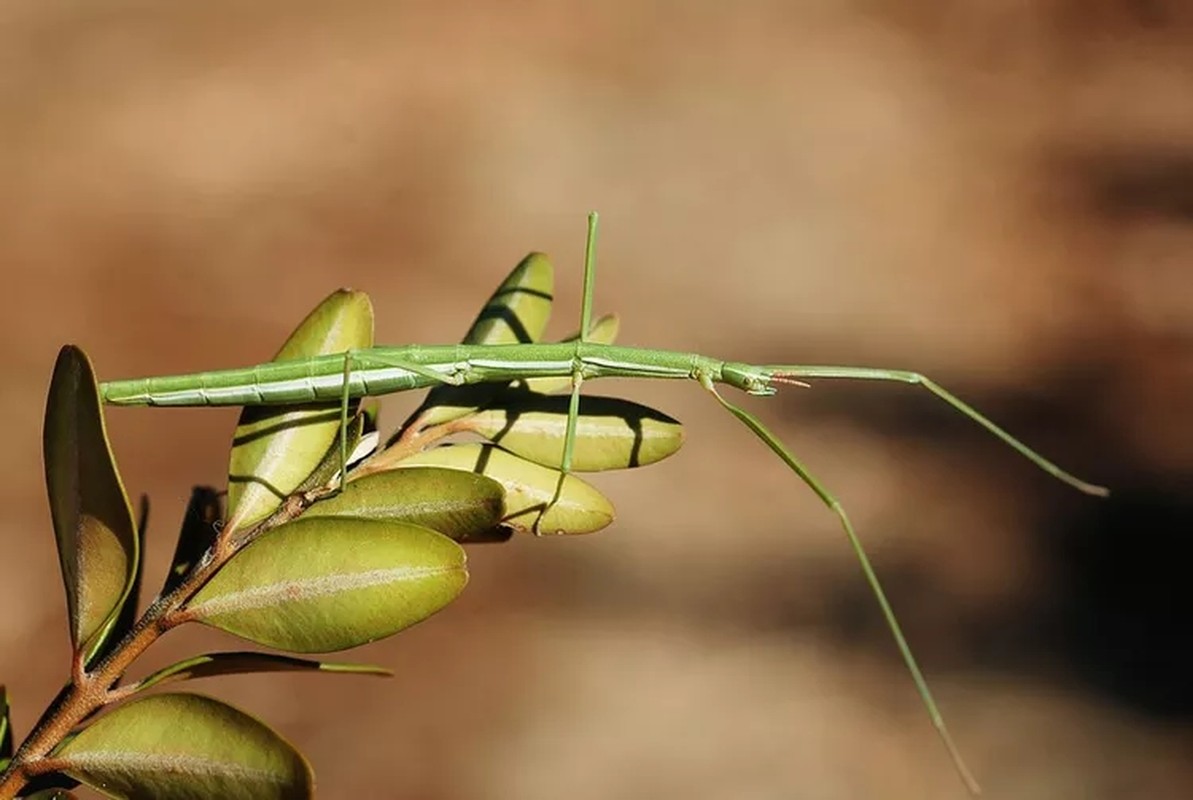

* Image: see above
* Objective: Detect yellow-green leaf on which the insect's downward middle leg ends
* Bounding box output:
[397,444,613,534]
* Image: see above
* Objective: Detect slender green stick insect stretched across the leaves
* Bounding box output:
[101,213,1108,794]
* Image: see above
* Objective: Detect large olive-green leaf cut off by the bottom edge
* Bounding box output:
[50,694,315,800]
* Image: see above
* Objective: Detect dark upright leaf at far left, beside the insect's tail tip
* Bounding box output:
[43,345,140,653]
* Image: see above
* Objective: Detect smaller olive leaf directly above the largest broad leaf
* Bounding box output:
[303,467,509,542]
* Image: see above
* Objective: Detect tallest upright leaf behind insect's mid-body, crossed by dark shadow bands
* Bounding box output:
[402,253,555,428]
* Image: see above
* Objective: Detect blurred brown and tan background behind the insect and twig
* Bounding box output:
[0,0,1193,800]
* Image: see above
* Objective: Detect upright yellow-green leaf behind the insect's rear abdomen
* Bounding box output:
[228,289,373,528]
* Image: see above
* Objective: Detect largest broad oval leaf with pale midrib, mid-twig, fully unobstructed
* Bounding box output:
[186,517,468,652]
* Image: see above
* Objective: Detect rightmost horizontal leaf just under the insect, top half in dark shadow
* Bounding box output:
[459,393,684,472]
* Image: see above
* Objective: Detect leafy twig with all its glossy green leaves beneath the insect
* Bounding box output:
[0,254,682,800]
